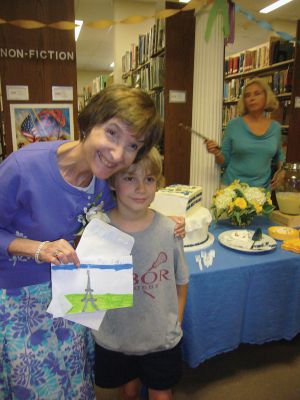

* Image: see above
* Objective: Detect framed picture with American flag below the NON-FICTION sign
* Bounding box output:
[10,103,74,150]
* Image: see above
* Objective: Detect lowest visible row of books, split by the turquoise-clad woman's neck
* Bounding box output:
[223,100,291,128]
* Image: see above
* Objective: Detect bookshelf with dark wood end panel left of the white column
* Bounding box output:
[122,2,195,185]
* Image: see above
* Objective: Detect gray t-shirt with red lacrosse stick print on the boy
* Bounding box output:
[93,213,189,355]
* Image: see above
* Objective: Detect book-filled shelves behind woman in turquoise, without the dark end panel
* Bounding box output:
[223,37,295,129]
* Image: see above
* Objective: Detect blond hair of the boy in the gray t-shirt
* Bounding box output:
[108,147,165,189]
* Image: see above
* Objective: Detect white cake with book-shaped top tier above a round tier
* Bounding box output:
[151,185,212,250]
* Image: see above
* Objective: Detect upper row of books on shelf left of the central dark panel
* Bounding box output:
[122,19,165,74]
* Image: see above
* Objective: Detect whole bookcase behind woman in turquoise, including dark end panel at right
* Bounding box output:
[223,21,300,162]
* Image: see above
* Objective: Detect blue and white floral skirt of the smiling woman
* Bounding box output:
[0,283,95,400]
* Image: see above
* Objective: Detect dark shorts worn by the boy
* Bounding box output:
[95,342,182,390]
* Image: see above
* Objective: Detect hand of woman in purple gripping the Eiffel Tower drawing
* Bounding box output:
[38,239,80,267]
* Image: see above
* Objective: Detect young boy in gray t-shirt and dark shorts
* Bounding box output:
[94,148,188,400]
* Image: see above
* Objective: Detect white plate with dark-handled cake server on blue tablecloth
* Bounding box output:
[218,229,277,253]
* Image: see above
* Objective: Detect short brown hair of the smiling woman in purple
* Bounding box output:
[78,84,162,159]
